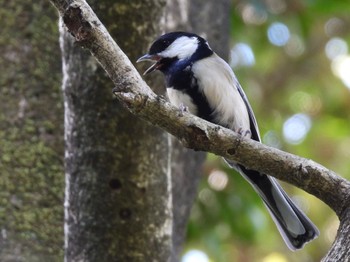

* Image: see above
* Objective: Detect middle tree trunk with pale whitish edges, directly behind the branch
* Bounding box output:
[61,0,172,261]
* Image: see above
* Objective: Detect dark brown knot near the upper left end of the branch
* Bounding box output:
[63,4,92,42]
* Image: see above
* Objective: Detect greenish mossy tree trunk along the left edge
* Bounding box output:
[0,0,64,262]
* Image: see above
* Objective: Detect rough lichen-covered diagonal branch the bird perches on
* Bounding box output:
[52,0,350,261]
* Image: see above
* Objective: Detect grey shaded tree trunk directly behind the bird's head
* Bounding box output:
[165,0,230,262]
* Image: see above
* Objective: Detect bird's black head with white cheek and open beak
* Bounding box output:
[137,32,213,75]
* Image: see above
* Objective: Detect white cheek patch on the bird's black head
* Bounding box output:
[158,36,198,59]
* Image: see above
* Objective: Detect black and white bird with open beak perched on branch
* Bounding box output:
[137,32,319,250]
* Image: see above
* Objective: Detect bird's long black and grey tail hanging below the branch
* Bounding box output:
[227,161,319,250]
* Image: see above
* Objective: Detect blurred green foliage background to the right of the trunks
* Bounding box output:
[186,0,350,262]
